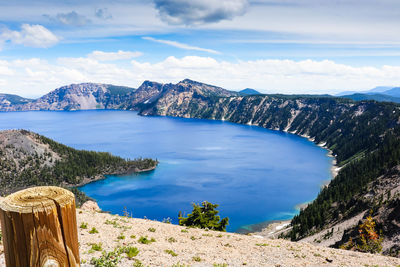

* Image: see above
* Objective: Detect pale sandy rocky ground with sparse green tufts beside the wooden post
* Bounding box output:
[0,204,400,267]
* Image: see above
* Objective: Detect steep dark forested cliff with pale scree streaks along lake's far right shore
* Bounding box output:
[141,91,400,166]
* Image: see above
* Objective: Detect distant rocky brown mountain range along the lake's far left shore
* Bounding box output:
[0,79,238,111]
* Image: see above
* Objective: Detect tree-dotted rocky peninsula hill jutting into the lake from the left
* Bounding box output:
[0,130,157,203]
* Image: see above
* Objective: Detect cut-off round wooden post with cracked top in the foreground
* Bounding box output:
[0,186,80,267]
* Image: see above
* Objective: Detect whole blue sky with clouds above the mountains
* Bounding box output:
[0,0,400,98]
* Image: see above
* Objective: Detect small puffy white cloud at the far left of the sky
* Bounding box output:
[0,24,59,48]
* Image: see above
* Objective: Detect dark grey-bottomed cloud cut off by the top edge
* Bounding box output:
[153,0,248,25]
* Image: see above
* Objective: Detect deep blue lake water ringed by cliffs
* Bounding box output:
[0,111,332,231]
